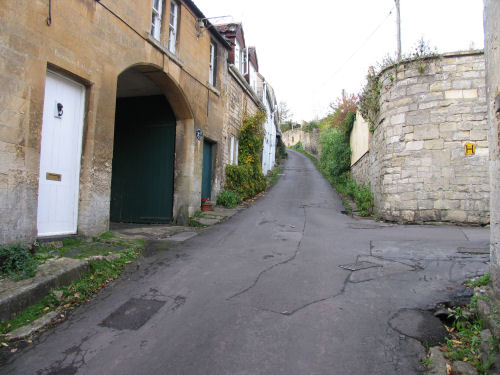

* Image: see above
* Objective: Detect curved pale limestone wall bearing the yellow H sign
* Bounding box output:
[368,51,490,224]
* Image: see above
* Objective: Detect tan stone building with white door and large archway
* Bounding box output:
[0,0,266,243]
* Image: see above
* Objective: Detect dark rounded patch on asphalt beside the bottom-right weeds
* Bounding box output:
[389,309,447,346]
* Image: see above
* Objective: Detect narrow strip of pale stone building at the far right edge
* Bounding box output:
[484,0,500,301]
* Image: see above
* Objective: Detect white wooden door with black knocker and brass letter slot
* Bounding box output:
[37,71,85,236]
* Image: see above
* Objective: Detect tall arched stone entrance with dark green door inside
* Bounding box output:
[110,65,194,223]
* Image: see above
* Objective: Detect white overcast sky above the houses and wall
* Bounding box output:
[194,0,484,122]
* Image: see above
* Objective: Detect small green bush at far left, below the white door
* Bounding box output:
[0,243,38,280]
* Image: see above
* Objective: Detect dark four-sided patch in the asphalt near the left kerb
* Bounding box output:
[101,298,165,330]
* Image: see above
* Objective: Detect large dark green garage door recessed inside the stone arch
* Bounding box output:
[111,96,175,223]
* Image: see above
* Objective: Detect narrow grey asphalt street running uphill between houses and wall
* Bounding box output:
[0,151,489,375]
